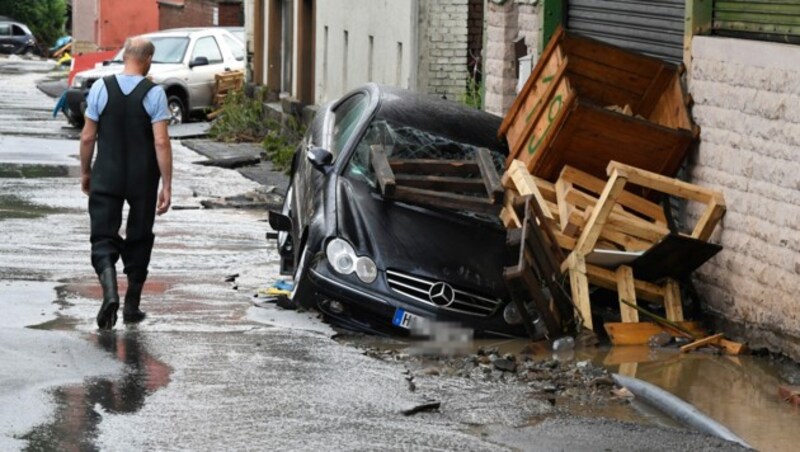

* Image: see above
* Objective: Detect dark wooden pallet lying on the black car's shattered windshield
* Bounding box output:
[371,145,504,215]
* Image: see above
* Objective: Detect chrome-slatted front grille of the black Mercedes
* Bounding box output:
[386,270,502,317]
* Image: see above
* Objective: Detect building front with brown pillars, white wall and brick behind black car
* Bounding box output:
[245,0,484,104]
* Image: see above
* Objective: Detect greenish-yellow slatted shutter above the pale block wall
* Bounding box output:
[713,0,800,43]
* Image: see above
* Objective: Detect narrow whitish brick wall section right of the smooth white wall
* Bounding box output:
[417,0,470,100]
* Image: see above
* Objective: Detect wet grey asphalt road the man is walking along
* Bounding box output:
[0,60,744,451]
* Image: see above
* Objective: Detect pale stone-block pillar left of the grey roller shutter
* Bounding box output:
[484,0,541,115]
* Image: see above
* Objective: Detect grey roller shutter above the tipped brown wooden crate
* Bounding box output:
[566,0,685,63]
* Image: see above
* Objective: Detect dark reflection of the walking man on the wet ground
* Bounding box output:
[22,330,171,451]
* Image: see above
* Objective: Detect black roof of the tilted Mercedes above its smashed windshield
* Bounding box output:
[372,85,508,154]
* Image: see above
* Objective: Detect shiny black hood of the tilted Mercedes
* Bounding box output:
[336,177,508,298]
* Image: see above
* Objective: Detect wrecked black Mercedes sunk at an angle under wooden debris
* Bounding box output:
[270,84,524,336]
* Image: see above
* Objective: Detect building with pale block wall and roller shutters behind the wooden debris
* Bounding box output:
[484,0,800,360]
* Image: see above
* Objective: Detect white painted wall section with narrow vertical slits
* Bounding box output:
[315,0,417,104]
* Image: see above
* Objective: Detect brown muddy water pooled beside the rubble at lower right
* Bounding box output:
[346,336,800,451]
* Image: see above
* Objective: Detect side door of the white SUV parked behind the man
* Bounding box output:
[188,36,230,109]
